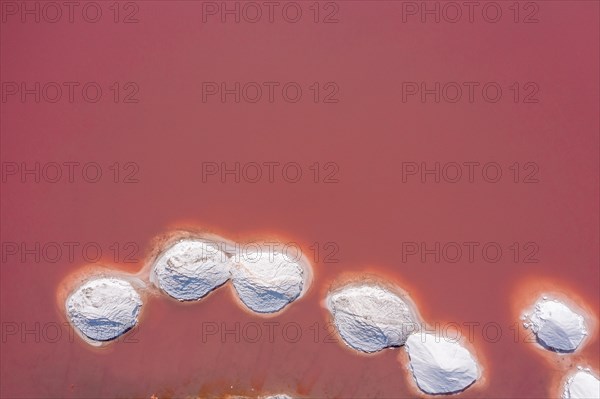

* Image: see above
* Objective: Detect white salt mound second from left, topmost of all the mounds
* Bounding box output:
[152,239,231,301]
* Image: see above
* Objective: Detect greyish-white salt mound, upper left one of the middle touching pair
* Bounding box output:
[327,284,418,352]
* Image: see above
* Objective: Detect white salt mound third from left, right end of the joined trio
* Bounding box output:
[231,251,308,313]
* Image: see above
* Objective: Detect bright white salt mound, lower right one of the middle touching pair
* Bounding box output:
[405,333,479,395]
